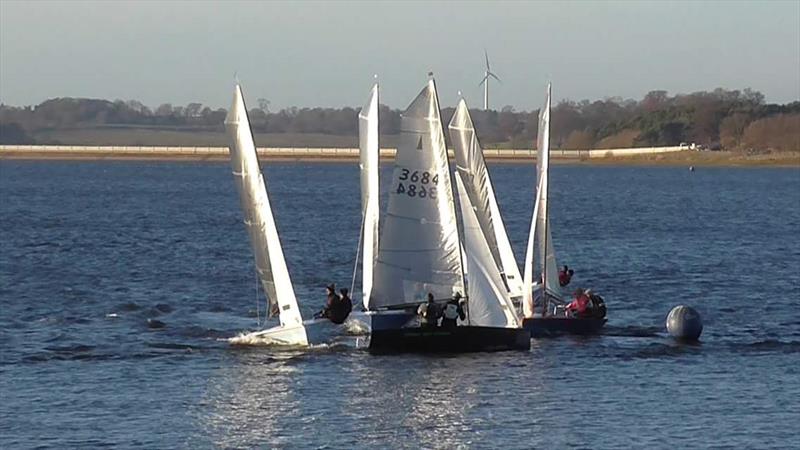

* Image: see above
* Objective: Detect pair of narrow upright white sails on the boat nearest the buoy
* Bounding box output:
[523,84,562,316]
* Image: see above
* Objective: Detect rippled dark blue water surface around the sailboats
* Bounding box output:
[0,161,800,448]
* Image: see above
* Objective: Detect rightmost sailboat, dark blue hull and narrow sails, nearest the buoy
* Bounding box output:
[523,84,606,337]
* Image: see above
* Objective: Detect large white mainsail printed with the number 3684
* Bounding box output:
[370,79,464,309]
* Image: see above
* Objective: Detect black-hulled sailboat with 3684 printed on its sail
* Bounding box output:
[362,78,530,353]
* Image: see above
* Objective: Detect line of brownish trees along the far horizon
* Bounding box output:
[0,89,800,151]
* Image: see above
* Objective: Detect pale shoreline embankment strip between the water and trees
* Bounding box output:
[0,150,800,168]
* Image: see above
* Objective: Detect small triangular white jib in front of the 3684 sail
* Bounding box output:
[455,172,519,328]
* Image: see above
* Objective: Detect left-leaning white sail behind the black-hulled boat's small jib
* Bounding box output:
[448,99,522,297]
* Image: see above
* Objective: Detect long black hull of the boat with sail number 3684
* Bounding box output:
[369,326,531,354]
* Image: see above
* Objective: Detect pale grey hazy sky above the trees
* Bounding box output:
[0,0,800,110]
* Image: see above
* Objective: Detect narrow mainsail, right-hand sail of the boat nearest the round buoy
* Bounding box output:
[536,84,562,298]
